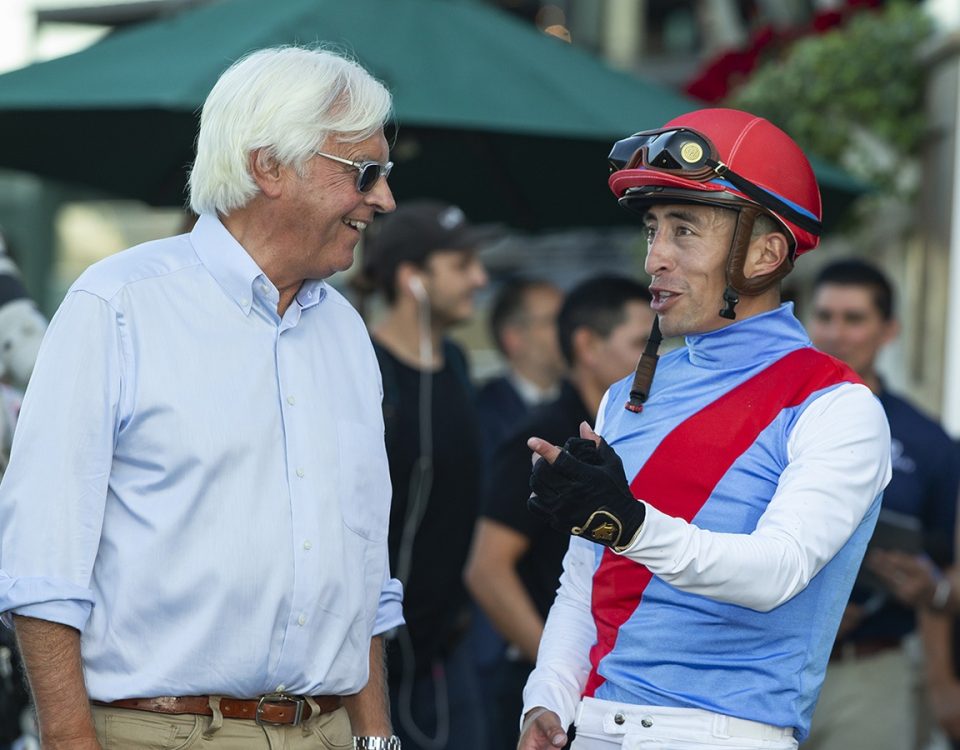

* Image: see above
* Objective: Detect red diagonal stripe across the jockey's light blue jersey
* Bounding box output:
[584,348,860,696]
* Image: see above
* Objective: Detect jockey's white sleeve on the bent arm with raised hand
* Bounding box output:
[623,383,890,612]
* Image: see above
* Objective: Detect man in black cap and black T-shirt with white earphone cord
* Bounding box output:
[364,201,487,750]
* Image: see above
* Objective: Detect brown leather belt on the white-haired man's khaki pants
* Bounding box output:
[93,693,343,726]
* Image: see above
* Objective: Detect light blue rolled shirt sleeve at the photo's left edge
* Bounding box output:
[0,291,123,631]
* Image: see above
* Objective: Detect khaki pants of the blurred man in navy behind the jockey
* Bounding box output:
[803,648,917,750]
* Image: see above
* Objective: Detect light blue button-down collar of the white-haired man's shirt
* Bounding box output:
[190,214,327,315]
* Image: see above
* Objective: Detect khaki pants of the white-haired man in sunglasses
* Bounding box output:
[92,698,353,750]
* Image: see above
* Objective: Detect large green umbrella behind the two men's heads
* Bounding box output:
[0,0,863,228]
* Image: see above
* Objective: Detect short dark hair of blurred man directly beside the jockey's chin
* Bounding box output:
[557,275,651,365]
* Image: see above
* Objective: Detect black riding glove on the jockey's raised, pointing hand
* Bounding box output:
[527,438,647,552]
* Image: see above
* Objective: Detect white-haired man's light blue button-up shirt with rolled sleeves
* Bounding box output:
[0,216,402,701]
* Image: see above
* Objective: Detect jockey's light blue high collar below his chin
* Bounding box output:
[686,302,811,370]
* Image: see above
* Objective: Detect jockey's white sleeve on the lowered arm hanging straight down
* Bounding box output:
[520,539,597,727]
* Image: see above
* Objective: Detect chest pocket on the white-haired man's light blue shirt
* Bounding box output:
[337,420,391,542]
